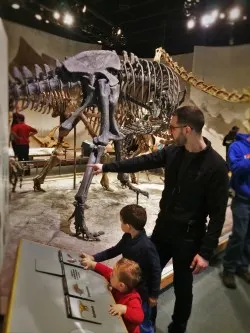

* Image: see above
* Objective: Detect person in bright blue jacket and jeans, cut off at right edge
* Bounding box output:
[222,134,250,289]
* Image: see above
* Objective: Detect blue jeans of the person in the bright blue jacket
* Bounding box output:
[223,196,250,273]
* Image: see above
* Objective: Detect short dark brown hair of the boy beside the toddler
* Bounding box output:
[120,204,147,230]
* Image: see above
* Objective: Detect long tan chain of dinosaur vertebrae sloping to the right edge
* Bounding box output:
[154,47,250,103]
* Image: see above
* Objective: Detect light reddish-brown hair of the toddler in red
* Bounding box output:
[115,258,141,291]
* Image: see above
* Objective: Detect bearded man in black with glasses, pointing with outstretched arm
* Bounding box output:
[90,106,229,333]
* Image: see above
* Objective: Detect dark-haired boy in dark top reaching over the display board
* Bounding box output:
[81,205,161,333]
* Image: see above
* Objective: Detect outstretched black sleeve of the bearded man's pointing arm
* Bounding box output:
[103,147,168,173]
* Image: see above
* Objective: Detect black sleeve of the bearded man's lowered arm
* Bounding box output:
[199,163,229,260]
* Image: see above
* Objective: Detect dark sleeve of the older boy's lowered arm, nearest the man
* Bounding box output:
[147,244,161,298]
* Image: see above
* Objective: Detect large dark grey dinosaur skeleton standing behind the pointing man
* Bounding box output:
[10,50,184,240]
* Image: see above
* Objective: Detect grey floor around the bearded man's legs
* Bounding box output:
[156,265,250,333]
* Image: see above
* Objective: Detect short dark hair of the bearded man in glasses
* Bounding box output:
[173,106,205,134]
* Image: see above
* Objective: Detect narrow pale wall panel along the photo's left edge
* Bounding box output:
[0,19,9,270]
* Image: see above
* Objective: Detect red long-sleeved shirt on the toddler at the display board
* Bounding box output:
[95,263,144,333]
